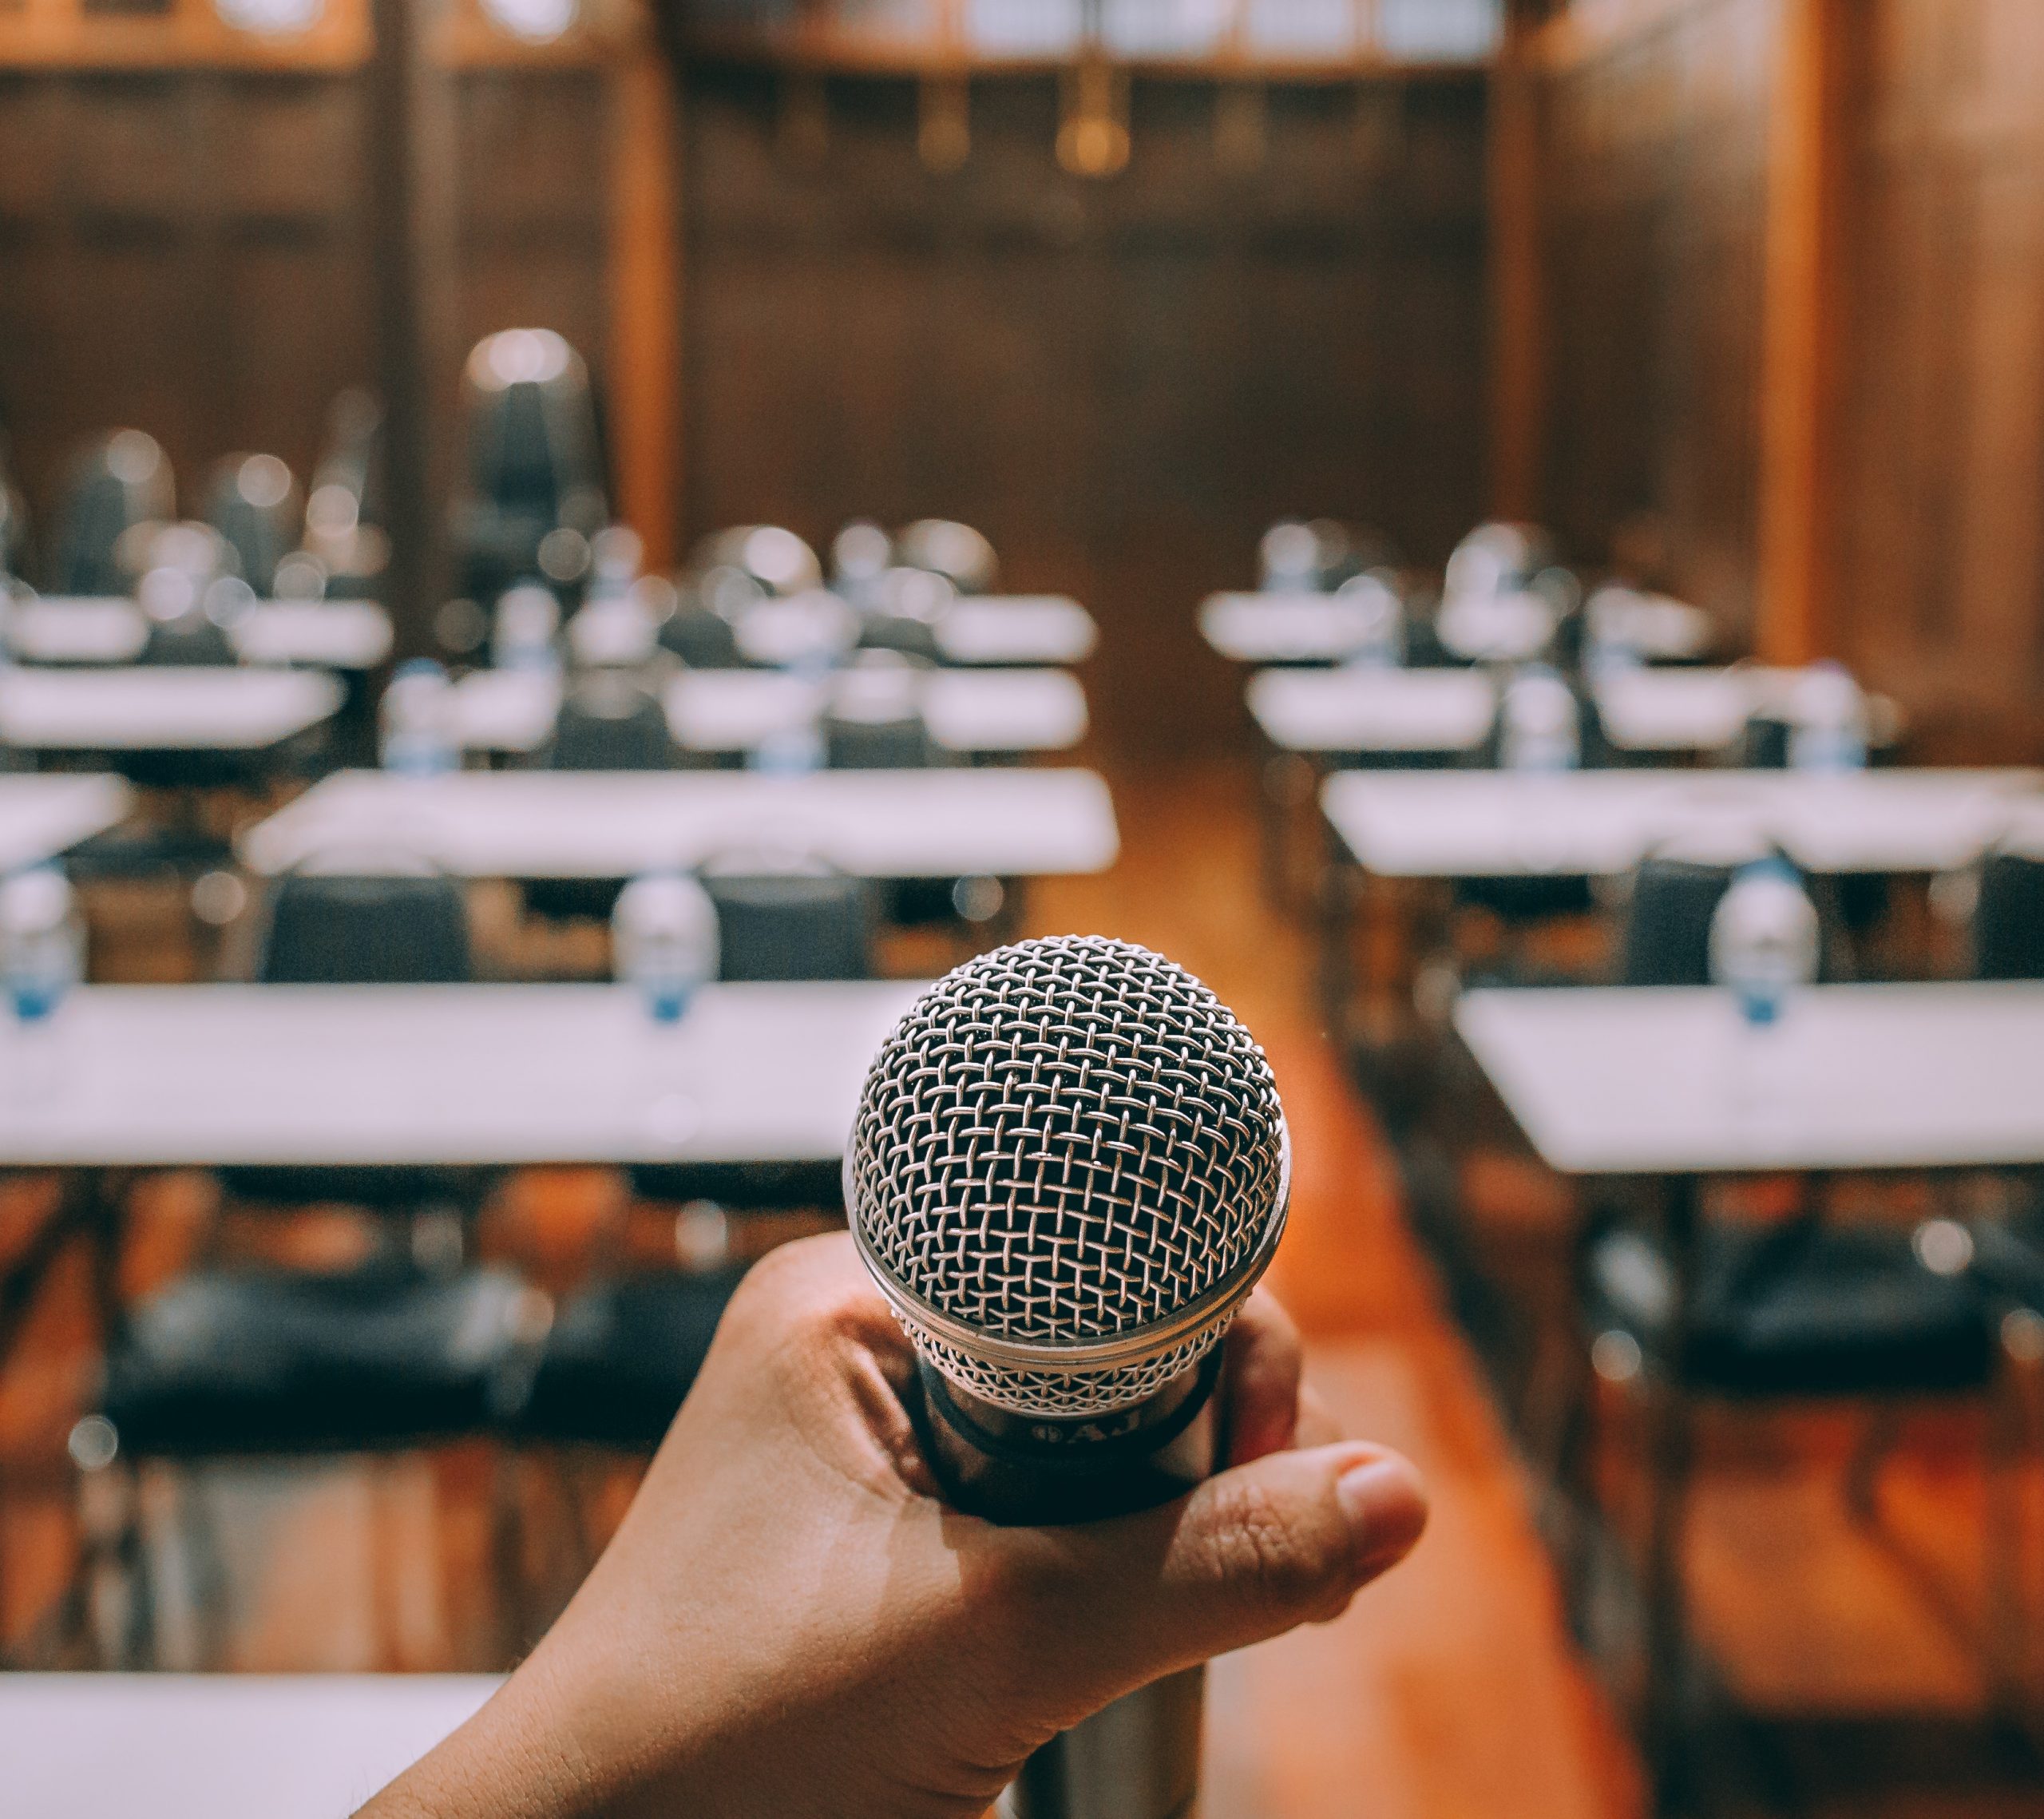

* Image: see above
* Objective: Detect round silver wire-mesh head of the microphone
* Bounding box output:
[846,936,1289,1417]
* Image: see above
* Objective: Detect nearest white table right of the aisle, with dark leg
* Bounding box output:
[1456,983,2044,1776]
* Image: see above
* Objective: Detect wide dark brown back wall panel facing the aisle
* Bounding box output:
[683,72,1486,748]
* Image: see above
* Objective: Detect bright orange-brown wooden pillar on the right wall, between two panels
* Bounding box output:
[1753,0,1858,662]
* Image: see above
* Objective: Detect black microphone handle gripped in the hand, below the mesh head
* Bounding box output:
[920,1347,1224,1819]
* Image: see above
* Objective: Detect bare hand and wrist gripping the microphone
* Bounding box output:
[364,1237,1427,1819]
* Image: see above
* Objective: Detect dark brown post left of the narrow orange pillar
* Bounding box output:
[368,0,460,656]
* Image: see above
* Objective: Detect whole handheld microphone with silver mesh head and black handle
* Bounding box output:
[844,936,1292,1819]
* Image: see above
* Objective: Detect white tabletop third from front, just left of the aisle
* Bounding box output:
[454,668,1085,756]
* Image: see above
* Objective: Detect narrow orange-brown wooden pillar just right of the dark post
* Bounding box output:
[609,30,683,570]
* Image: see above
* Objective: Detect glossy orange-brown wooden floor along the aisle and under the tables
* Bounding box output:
[0,763,2044,1819]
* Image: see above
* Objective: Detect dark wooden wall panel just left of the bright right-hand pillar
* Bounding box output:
[1541,0,1774,632]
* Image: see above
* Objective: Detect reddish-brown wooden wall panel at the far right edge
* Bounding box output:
[1833,0,2044,756]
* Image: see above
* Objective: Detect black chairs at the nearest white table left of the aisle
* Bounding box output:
[59,854,875,1659]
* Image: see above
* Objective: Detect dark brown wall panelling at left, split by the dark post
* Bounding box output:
[0,65,607,568]
